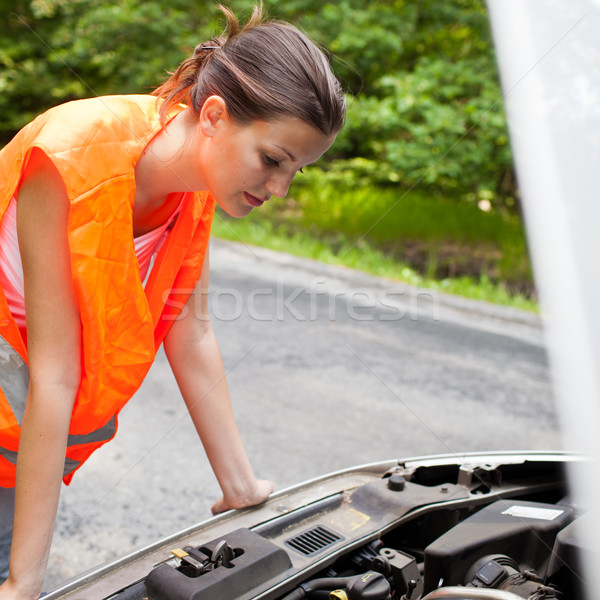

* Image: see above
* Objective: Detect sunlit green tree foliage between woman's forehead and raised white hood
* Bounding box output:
[260,0,516,209]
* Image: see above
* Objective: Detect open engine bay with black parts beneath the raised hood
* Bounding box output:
[48,460,587,600]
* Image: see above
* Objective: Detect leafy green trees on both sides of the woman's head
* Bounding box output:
[0,0,515,205]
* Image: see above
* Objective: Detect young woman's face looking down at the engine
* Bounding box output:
[196,99,335,217]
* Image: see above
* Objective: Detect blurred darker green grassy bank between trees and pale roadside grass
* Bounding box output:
[288,178,534,296]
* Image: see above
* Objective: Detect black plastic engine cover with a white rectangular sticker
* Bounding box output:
[424,500,574,593]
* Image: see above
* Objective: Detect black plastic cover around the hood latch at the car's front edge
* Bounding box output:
[145,529,292,600]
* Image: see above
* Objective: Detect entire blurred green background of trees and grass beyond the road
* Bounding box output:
[0,0,535,309]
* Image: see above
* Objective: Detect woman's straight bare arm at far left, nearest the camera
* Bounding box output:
[0,150,81,600]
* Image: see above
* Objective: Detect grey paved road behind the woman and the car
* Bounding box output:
[46,242,561,588]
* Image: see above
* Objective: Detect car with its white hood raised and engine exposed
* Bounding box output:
[46,0,600,600]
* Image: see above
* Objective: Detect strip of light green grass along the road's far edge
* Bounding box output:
[213,199,537,311]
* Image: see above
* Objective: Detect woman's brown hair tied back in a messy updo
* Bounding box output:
[153,5,346,135]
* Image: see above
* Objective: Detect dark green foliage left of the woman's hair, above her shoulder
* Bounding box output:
[0,0,214,142]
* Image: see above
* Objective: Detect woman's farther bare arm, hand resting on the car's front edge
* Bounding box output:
[165,246,273,514]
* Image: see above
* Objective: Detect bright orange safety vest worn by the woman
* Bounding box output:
[0,96,215,487]
